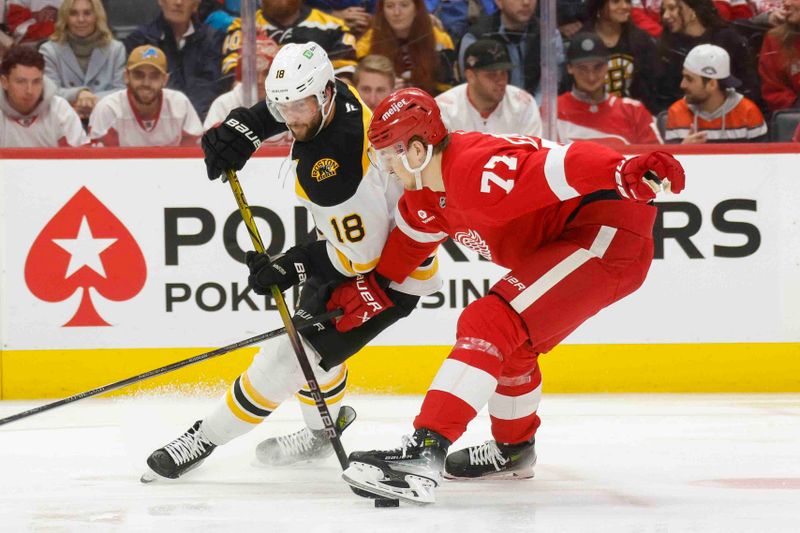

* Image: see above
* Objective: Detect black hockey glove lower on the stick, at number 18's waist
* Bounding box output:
[244,246,309,295]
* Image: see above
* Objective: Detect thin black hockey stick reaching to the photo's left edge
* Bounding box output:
[0,309,342,426]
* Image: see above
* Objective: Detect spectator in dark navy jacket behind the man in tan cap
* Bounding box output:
[125,0,225,117]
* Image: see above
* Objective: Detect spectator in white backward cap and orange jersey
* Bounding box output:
[665,44,767,144]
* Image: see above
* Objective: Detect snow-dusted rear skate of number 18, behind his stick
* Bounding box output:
[256,405,356,466]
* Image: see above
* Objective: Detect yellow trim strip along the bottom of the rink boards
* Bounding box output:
[0,343,800,400]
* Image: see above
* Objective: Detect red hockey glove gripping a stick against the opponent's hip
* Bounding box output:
[328,272,394,332]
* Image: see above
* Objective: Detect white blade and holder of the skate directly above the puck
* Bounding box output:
[342,462,436,506]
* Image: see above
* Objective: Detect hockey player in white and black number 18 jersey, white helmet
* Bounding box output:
[143,42,441,481]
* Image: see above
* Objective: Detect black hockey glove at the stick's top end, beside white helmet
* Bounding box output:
[200,107,261,181]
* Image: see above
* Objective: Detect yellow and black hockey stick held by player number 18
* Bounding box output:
[226,170,347,470]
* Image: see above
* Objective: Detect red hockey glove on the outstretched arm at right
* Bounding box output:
[615,152,686,202]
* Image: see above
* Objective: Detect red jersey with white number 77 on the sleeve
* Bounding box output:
[377,132,636,281]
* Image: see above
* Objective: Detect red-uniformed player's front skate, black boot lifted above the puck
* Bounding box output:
[342,428,450,505]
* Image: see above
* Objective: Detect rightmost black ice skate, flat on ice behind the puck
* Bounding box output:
[444,439,536,479]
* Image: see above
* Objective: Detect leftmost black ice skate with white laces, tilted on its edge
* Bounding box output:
[141,420,217,483]
